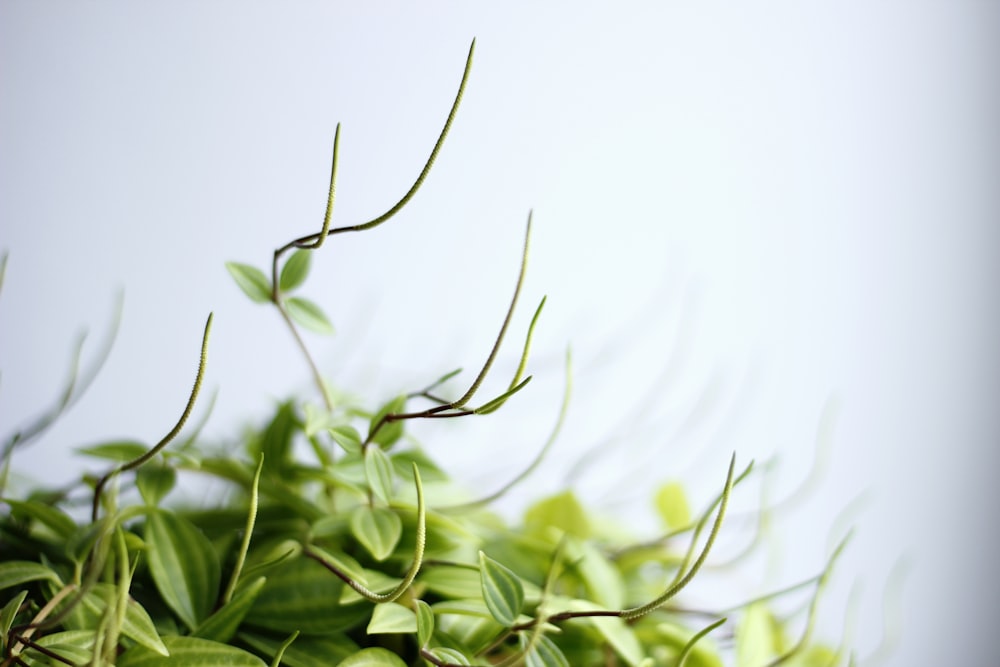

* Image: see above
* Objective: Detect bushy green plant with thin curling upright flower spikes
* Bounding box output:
[0,40,846,667]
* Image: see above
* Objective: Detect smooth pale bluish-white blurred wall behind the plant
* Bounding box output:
[0,0,1000,665]
